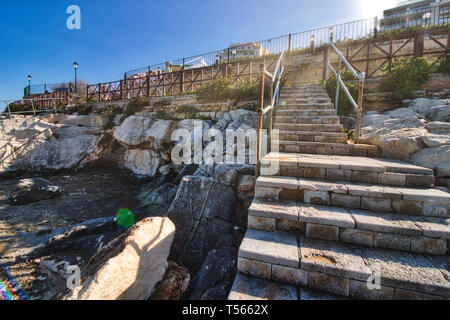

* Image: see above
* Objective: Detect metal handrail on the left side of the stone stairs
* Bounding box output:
[255,51,285,178]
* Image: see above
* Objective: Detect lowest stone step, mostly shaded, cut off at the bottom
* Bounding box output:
[228,272,347,301]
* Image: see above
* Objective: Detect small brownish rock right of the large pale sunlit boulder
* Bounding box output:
[150,261,191,300]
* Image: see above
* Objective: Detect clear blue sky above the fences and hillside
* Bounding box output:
[0,0,395,100]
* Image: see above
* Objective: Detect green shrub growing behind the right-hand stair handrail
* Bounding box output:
[325,71,358,116]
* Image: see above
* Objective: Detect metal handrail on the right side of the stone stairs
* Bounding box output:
[325,39,366,143]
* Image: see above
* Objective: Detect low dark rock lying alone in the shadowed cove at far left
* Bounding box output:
[9,178,62,205]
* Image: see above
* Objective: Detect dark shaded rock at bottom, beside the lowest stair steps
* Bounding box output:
[188,249,237,300]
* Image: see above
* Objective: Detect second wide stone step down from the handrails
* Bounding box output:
[255,176,450,218]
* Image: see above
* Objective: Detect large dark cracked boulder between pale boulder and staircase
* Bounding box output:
[168,176,236,272]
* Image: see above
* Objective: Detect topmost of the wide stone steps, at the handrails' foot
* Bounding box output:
[261,152,435,188]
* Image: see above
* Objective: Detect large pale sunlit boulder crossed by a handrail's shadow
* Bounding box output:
[64,217,175,300]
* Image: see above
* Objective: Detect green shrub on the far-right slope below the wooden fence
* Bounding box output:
[378,57,433,103]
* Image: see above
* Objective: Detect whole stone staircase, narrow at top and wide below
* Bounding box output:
[229,85,450,300]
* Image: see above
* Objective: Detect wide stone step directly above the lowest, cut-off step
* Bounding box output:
[238,229,450,299]
